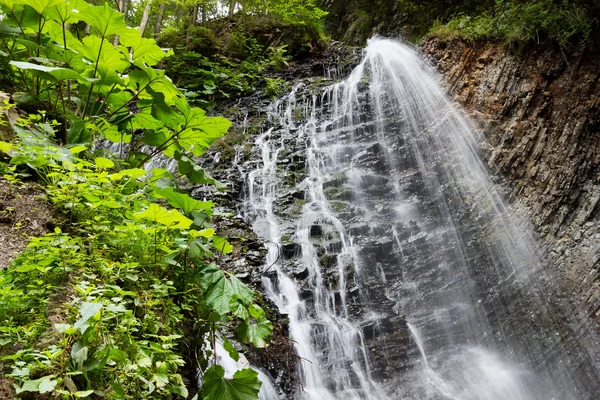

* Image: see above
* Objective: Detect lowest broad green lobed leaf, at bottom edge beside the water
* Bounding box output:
[202,365,261,400]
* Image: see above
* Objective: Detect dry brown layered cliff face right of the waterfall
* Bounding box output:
[421,38,600,366]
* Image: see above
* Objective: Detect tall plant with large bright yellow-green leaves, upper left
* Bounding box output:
[0,0,229,161]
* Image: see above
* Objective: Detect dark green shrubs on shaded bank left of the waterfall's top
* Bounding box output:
[159,14,323,108]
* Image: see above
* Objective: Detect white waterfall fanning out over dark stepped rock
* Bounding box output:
[246,38,598,400]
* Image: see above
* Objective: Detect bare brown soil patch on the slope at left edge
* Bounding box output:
[0,178,54,268]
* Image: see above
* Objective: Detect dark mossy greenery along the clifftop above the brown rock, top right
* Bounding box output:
[326,0,600,47]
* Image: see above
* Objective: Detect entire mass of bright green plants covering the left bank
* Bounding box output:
[0,0,272,399]
